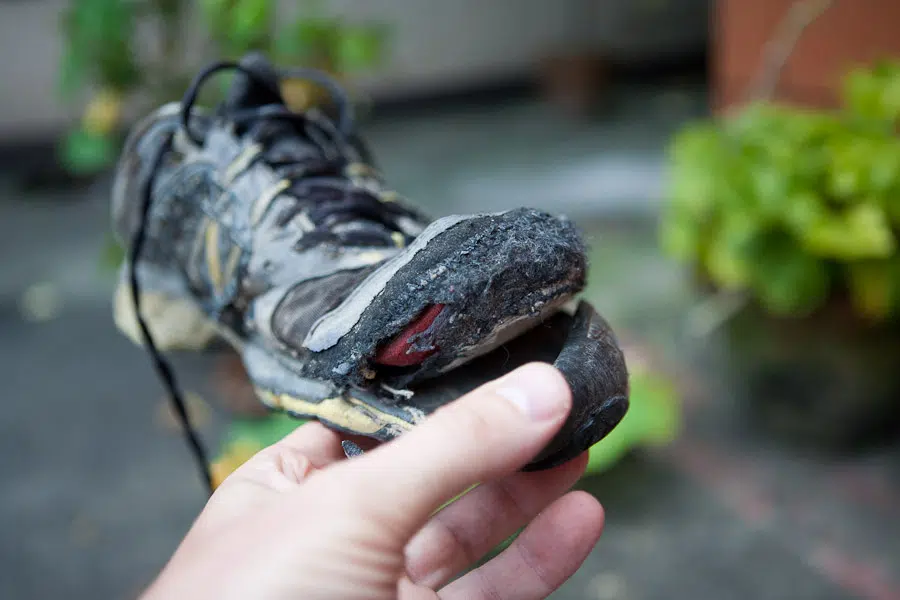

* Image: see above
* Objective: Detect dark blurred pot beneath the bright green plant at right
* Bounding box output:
[721,301,900,450]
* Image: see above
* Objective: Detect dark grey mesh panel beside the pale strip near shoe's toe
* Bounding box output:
[272,268,372,349]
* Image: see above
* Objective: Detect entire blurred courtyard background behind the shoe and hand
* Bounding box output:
[0,0,900,600]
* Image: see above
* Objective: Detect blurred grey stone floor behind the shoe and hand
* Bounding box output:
[0,86,900,600]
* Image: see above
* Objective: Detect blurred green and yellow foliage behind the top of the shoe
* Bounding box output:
[59,0,388,174]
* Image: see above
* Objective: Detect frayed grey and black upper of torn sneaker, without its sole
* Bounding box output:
[113,55,587,394]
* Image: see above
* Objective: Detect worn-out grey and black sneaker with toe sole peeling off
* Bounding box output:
[112,54,628,469]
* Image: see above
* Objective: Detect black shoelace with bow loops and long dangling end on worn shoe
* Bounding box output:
[128,61,384,494]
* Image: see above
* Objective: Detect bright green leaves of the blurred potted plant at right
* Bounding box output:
[660,62,900,320]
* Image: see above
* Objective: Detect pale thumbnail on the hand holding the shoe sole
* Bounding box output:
[497,365,568,421]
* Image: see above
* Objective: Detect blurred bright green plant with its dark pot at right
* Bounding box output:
[661,62,900,447]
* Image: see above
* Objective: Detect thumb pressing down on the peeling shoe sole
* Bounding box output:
[330,363,572,541]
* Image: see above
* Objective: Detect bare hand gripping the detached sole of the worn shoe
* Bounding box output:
[145,364,603,600]
